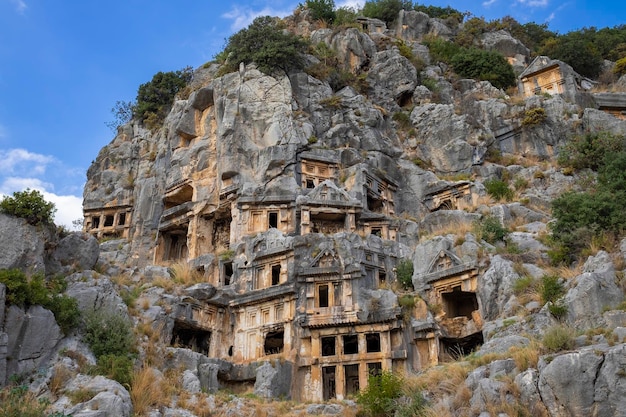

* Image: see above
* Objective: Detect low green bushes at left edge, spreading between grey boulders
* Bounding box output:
[0,269,80,334]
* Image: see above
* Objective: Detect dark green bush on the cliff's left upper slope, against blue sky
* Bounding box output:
[136,67,192,129]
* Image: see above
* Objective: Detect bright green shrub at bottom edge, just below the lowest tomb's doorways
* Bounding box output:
[357,371,404,417]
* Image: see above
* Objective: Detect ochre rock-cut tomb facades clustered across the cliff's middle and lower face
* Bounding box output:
[85,153,482,400]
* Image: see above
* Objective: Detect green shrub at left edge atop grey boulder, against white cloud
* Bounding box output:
[0,188,56,225]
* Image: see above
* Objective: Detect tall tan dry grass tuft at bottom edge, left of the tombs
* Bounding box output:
[130,364,169,416]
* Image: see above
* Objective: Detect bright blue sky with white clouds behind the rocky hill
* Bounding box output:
[0,0,626,227]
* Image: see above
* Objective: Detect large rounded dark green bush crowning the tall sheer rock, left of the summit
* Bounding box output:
[219,16,308,74]
